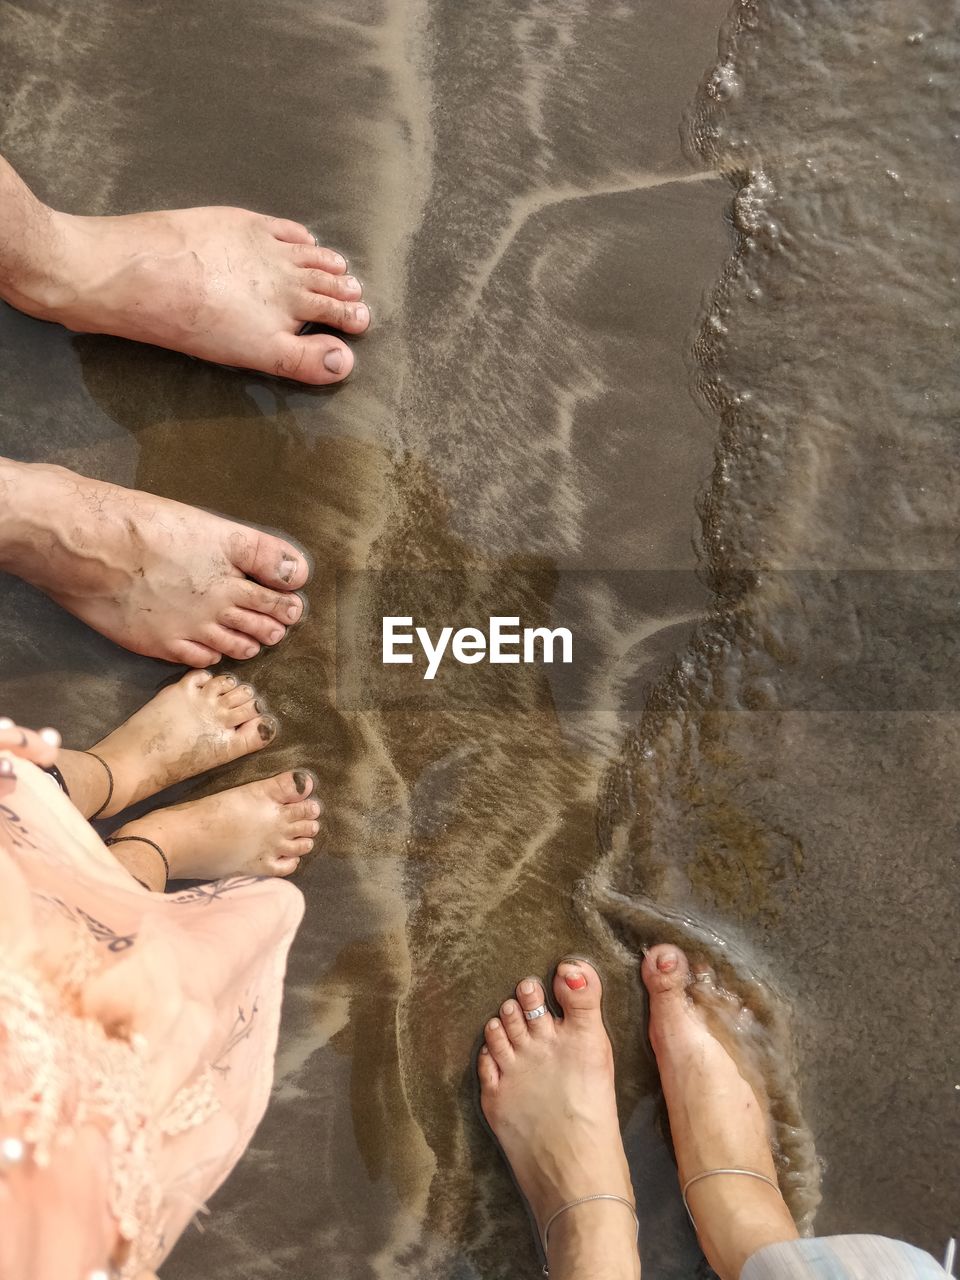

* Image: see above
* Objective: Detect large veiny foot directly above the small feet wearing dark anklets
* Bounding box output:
[0,458,310,667]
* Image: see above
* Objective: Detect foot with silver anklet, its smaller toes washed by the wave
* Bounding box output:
[641,946,797,1280]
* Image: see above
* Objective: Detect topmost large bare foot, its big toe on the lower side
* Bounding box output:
[0,160,370,385]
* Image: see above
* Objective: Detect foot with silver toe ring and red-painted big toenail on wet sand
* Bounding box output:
[477,960,640,1280]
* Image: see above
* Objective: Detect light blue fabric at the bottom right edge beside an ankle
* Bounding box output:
[740,1235,946,1280]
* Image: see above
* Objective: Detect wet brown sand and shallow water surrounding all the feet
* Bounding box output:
[0,0,960,1280]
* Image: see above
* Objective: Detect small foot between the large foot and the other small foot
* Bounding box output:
[82,671,278,818]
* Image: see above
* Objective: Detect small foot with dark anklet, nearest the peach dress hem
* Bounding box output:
[109,769,323,890]
